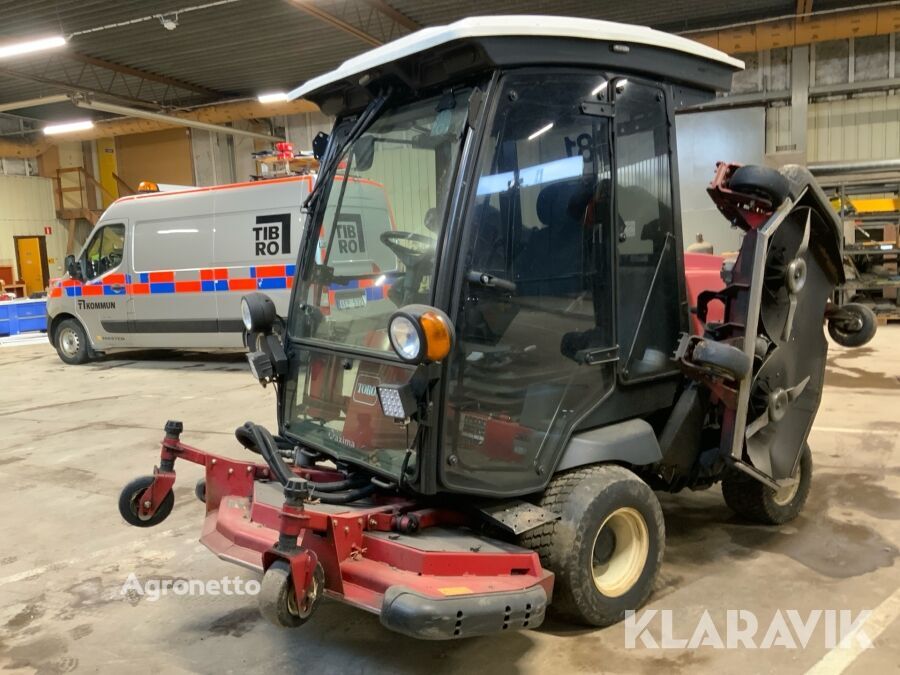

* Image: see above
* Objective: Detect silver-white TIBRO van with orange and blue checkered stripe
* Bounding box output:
[47,176,312,364]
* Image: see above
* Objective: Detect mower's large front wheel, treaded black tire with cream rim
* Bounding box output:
[522,465,665,626]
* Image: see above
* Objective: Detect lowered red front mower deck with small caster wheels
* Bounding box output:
[123,421,553,639]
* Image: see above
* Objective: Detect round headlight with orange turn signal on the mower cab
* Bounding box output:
[388,305,454,363]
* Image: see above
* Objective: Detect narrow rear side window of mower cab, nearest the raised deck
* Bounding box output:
[614,79,685,380]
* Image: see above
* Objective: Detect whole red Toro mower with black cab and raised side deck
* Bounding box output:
[119,16,855,639]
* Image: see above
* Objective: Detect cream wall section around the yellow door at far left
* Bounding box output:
[0,176,66,278]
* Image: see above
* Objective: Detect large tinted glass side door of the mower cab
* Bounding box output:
[440,69,617,495]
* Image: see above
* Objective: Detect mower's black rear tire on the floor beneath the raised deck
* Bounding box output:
[722,444,812,525]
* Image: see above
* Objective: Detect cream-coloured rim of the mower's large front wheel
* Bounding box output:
[591,506,650,598]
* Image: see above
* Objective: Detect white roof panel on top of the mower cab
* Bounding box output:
[288,15,744,99]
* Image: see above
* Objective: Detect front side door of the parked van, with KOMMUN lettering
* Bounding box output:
[75,222,131,350]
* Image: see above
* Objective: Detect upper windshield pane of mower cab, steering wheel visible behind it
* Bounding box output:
[291,90,470,354]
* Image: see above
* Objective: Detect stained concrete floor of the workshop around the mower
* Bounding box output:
[0,326,900,675]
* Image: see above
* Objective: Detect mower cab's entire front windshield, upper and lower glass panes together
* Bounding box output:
[284,90,470,477]
